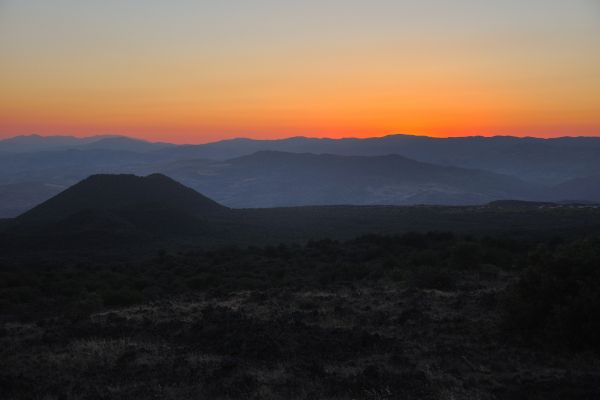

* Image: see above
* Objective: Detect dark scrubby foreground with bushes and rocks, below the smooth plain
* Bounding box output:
[0,232,600,399]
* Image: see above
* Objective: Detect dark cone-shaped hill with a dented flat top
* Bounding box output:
[18,174,227,222]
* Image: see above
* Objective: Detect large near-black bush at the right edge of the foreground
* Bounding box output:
[504,239,600,351]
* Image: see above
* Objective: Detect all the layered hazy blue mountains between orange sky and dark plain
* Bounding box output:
[0,135,600,217]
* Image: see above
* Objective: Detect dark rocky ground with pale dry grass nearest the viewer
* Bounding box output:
[0,272,600,400]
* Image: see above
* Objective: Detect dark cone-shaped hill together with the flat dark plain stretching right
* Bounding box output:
[0,173,600,256]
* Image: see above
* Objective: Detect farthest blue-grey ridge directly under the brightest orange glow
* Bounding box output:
[160,135,600,185]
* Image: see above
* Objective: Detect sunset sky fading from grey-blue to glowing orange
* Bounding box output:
[0,0,600,143]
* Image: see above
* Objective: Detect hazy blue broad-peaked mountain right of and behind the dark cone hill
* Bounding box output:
[151,151,544,207]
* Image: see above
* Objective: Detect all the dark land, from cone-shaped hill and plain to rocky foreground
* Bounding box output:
[0,173,600,399]
